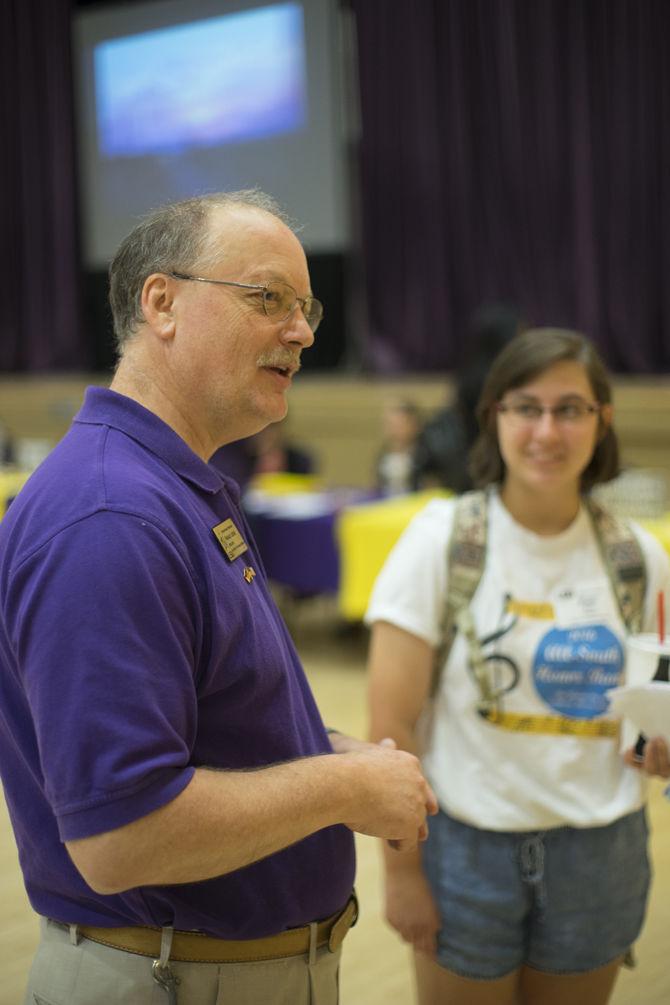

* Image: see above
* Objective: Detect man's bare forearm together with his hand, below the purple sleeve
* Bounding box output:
[67,745,433,894]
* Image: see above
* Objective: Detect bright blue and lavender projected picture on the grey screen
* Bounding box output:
[93,3,307,159]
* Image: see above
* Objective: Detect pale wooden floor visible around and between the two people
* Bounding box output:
[0,618,670,1005]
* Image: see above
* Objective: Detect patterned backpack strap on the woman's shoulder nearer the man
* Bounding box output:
[431,490,488,695]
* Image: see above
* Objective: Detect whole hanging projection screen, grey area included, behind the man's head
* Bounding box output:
[73,0,350,269]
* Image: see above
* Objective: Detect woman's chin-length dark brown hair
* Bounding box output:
[469,328,619,491]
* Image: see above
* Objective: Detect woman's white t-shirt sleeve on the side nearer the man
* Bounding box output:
[365,499,455,646]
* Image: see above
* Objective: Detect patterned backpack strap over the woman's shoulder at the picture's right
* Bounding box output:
[585,496,647,634]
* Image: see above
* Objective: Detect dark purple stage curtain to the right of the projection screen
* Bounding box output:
[349,0,670,373]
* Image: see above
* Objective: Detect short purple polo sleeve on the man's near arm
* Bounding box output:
[8,512,203,840]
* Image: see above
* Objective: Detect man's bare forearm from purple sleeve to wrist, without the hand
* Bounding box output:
[67,756,349,893]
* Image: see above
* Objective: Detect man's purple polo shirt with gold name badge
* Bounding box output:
[0,388,355,939]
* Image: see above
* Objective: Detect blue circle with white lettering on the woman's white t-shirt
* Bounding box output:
[532,624,624,719]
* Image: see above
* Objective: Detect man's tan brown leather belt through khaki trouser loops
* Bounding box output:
[58,893,359,963]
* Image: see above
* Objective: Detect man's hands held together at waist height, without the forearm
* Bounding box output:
[342,740,438,851]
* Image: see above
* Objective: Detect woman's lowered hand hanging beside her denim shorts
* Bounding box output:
[386,863,441,958]
